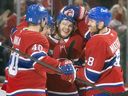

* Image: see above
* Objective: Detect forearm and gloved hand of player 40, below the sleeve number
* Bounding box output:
[33,48,76,82]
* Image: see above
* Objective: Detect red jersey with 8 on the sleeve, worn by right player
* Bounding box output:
[77,29,124,96]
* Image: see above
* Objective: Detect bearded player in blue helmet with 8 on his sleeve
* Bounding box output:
[77,6,125,96]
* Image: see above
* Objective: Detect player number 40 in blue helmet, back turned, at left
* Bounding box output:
[6,4,75,96]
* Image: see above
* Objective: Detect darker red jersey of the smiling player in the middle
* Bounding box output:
[47,34,84,96]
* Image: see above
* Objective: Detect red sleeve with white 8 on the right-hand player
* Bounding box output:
[77,38,107,83]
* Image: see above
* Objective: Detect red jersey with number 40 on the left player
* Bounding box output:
[6,29,59,96]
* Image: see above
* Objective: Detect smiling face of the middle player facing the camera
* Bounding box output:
[59,20,73,38]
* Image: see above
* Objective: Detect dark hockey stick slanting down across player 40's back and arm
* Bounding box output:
[0,38,124,96]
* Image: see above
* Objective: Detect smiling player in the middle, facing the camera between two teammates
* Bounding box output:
[47,14,84,96]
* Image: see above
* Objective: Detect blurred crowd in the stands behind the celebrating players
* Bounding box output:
[0,0,127,82]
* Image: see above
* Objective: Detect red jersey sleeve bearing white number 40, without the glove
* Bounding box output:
[22,34,59,73]
